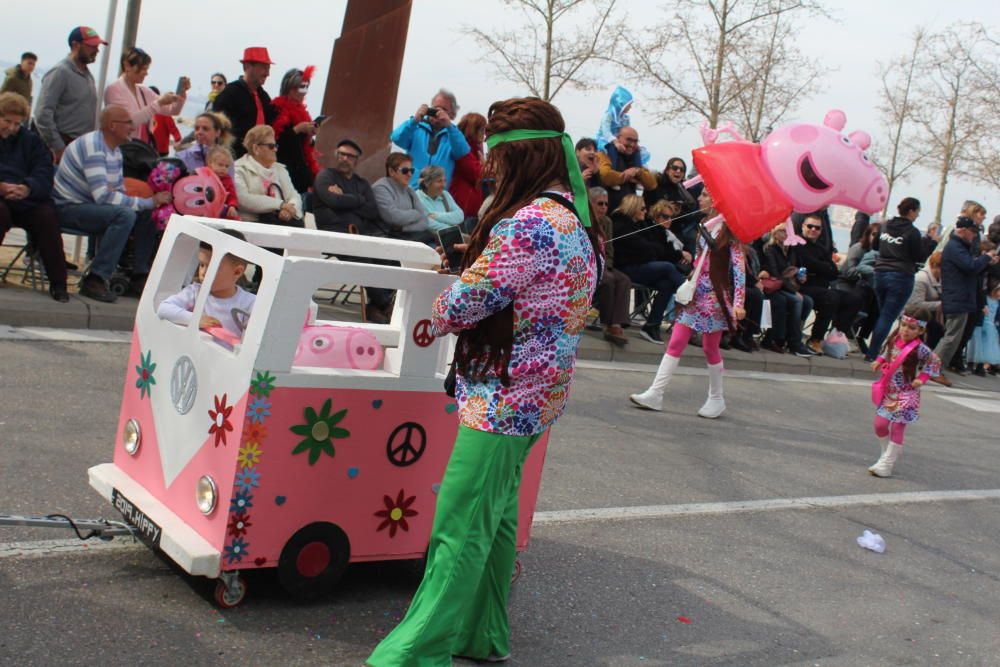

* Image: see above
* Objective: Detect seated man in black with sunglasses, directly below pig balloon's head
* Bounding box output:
[795,215,861,354]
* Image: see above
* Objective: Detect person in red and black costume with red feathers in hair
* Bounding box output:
[271,65,319,194]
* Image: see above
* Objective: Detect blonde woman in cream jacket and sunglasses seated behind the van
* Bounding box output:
[235,125,305,227]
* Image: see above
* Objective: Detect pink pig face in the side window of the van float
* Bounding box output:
[292,325,384,371]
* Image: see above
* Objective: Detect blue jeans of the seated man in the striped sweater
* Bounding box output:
[58,204,156,280]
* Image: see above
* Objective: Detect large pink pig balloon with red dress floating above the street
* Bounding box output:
[684,109,888,245]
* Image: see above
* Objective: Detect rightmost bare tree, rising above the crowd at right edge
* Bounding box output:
[914,23,995,222]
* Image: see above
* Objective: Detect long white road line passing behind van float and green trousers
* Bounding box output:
[7,489,1000,560]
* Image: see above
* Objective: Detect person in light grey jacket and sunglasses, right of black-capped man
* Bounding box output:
[372,153,436,245]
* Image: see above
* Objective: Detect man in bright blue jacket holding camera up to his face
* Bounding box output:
[389,89,471,189]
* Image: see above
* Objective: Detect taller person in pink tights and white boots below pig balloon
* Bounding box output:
[629,189,746,419]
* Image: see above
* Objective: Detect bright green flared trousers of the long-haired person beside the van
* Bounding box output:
[367,426,542,667]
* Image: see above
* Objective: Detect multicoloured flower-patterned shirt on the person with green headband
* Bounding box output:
[432,193,598,436]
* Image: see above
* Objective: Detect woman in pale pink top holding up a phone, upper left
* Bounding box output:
[104,47,191,143]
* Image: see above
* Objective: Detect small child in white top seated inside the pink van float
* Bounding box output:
[156,229,257,338]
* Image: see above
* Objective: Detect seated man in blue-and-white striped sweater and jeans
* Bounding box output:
[53,106,171,303]
